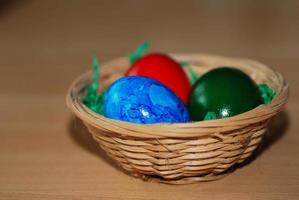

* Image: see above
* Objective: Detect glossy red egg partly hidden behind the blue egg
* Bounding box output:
[125,53,191,104]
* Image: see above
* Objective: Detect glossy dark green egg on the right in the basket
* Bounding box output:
[188,67,263,121]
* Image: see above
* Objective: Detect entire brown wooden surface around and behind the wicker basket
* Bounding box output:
[0,0,299,200]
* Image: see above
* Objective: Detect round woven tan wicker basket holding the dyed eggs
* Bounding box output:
[67,54,288,184]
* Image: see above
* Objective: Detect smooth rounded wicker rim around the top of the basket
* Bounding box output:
[66,53,289,138]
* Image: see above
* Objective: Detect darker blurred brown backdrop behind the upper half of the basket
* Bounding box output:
[0,0,299,95]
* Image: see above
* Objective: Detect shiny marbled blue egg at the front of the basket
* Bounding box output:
[104,76,190,124]
